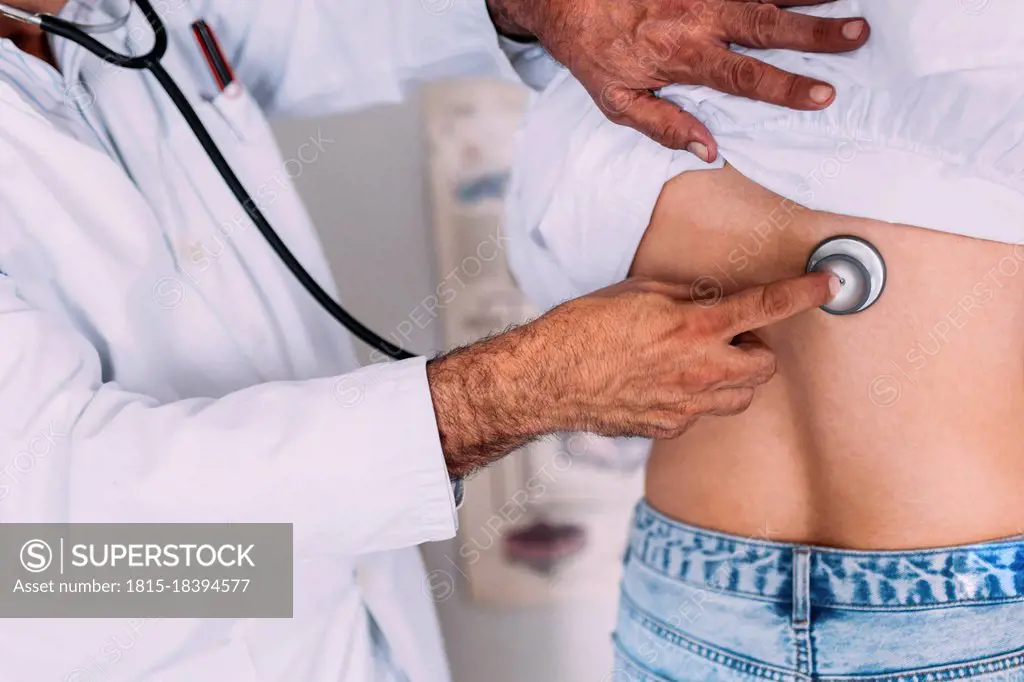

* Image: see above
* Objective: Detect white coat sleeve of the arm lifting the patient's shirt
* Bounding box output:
[194,0,554,116]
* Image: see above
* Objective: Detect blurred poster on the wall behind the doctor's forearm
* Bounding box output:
[423,79,647,605]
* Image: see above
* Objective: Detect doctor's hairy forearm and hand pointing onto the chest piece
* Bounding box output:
[427,273,839,476]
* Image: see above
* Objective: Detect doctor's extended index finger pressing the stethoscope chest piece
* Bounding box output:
[716,272,840,338]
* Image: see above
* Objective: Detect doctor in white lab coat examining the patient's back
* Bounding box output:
[0,0,867,682]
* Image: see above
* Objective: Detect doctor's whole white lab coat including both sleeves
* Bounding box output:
[0,0,552,682]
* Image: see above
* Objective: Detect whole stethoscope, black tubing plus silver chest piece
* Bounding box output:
[0,0,886,359]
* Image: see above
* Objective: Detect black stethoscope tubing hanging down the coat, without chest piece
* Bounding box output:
[0,0,415,359]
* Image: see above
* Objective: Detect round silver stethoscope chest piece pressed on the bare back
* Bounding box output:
[807,237,886,315]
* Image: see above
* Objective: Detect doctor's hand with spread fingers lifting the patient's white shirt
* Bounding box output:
[487,0,869,156]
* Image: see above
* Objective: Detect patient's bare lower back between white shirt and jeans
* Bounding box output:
[634,167,1024,549]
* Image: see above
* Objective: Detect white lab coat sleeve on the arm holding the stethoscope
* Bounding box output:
[0,260,456,554]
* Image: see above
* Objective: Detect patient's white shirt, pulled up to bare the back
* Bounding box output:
[508,0,1024,307]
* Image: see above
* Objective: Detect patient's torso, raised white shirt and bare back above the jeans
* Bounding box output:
[507,0,1024,548]
